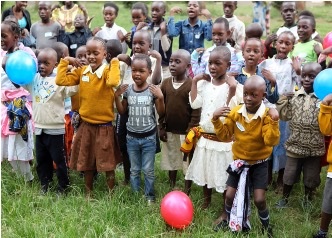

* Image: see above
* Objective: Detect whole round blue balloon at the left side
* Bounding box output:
[5,50,37,85]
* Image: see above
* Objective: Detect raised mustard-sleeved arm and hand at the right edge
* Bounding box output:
[318,94,332,135]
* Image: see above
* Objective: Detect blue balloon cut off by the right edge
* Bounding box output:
[314,69,332,100]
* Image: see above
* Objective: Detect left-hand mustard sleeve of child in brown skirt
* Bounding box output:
[55,59,82,86]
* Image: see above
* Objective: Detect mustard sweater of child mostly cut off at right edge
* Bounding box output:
[318,104,332,172]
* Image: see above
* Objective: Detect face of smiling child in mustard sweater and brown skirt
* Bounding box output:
[86,40,106,71]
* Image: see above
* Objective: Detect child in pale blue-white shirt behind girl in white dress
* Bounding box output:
[191,17,243,75]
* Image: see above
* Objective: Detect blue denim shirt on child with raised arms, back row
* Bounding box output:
[167,17,212,54]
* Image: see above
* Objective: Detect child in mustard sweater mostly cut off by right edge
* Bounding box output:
[314,94,332,238]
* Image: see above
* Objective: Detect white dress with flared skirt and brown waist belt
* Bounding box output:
[185,81,243,193]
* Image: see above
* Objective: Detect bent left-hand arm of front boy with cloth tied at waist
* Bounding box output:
[211,107,235,141]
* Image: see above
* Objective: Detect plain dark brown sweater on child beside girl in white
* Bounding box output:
[159,78,201,134]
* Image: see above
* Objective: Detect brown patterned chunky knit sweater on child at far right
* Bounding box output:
[276,88,325,158]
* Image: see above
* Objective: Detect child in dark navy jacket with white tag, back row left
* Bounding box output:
[58,14,92,57]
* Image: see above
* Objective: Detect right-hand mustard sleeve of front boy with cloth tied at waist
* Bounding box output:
[262,116,280,146]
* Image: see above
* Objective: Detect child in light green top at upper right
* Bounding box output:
[289,16,323,75]
